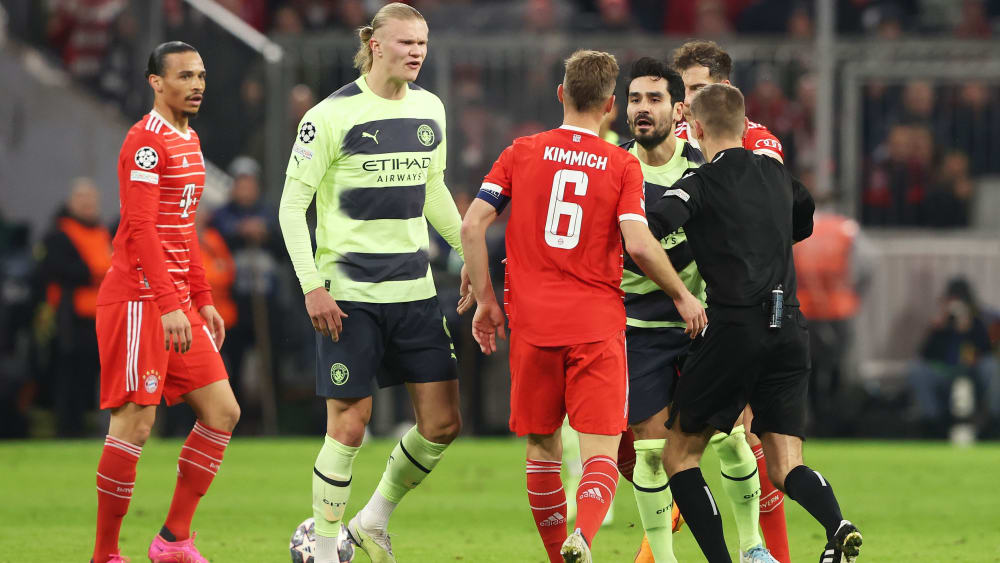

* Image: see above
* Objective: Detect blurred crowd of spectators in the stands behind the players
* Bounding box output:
[6,0,1000,228]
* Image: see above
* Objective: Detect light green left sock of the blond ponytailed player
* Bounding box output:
[313,435,361,538]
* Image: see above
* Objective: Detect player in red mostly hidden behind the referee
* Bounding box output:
[673,41,791,563]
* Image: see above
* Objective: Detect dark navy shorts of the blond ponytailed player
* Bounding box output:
[316,297,458,399]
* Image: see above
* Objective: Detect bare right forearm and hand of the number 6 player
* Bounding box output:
[620,220,708,338]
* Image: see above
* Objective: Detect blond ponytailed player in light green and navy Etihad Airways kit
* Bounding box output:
[279,3,462,563]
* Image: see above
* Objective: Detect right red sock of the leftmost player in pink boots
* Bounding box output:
[164,421,232,541]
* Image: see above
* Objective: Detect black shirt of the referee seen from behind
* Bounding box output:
[646,148,815,307]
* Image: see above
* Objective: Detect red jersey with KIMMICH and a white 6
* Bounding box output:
[480,125,646,346]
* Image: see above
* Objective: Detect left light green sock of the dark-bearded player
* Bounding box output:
[632,440,677,563]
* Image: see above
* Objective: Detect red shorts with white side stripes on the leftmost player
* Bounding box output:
[97,301,229,409]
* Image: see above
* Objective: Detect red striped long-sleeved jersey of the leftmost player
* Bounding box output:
[97,110,212,314]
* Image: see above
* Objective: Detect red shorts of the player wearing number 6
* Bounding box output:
[510,330,628,436]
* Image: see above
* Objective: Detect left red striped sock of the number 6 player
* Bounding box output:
[525,459,566,563]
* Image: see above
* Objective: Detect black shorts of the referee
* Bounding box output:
[667,306,810,438]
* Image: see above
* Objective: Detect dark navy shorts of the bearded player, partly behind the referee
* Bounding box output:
[625,326,691,424]
